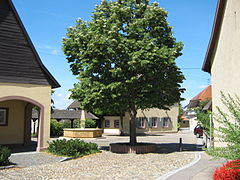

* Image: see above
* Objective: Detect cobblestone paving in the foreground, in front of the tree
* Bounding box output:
[0,151,195,180]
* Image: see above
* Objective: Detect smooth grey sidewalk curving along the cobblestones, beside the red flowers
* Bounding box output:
[166,152,225,180]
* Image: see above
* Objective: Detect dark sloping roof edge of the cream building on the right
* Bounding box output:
[202,0,227,73]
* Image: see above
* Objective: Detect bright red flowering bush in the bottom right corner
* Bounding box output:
[213,160,240,180]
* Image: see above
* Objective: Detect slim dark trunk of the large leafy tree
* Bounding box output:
[130,105,137,145]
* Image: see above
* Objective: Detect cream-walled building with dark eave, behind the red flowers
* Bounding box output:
[203,0,240,146]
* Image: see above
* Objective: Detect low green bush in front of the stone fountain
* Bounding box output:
[48,139,99,157]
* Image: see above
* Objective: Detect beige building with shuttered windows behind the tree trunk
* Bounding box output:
[102,104,179,134]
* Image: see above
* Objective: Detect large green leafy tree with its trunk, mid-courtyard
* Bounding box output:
[63,0,184,144]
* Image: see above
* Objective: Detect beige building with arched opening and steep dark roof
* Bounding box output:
[0,0,60,151]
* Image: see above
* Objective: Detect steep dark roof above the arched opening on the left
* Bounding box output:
[0,0,60,88]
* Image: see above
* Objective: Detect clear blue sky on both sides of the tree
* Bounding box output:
[12,0,217,109]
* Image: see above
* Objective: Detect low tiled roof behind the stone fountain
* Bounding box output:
[32,109,99,119]
